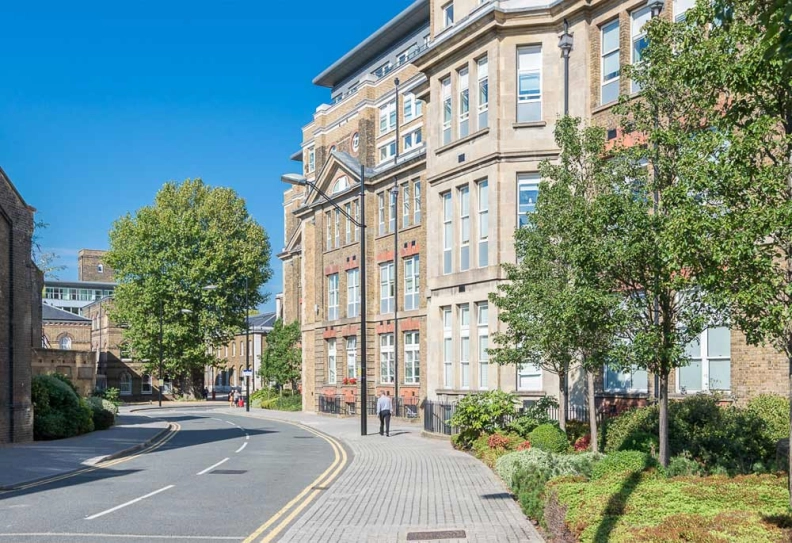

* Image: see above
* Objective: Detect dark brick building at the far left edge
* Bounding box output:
[0,169,38,444]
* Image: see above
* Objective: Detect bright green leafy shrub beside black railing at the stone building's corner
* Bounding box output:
[450,390,515,447]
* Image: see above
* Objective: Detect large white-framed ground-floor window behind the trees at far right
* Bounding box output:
[677,327,731,392]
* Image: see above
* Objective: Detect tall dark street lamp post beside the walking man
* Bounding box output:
[281,164,368,436]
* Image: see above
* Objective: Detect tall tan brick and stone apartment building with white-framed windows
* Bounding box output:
[280,0,787,410]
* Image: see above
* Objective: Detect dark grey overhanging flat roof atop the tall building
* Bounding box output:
[313,0,429,88]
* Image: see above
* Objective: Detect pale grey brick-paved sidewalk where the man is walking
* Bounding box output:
[227,409,543,543]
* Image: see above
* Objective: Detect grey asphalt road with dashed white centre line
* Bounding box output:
[0,409,336,543]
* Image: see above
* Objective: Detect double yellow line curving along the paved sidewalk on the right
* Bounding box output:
[243,419,347,543]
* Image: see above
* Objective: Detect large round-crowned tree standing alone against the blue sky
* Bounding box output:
[107,179,272,393]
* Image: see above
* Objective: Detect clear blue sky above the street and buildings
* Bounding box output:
[0,0,412,309]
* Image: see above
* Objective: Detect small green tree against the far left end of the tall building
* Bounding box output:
[259,319,302,390]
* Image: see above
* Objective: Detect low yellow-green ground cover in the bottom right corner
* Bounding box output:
[547,470,792,543]
